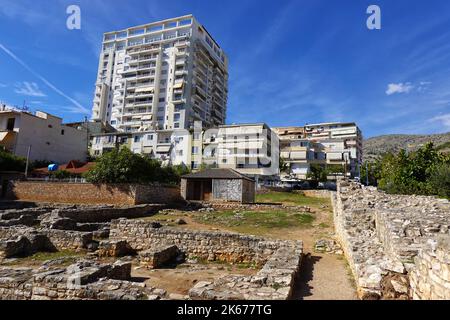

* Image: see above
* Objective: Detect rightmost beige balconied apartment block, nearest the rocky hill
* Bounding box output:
[274,122,362,180]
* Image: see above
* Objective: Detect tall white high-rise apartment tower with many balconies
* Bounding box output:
[92,15,228,132]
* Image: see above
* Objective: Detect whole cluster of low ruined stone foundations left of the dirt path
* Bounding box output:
[0,203,302,300]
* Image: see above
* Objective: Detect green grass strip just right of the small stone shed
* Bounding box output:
[256,192,331,210]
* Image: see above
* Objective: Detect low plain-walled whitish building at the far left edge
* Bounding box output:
[0,108,88,164]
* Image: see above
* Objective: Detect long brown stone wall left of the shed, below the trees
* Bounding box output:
[6,181,181,205]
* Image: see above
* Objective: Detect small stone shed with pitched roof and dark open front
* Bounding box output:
[181,169,255,203]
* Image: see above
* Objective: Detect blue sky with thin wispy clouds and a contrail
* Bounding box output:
[0,0,450,137]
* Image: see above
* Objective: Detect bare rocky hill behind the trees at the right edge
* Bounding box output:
[364,132,450,160]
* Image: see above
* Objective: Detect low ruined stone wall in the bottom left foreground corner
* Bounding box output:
[0,261,164,300]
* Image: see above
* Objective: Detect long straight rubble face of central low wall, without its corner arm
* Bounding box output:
[110,219,292,265]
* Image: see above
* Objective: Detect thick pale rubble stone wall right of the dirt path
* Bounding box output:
[333,181,450,299]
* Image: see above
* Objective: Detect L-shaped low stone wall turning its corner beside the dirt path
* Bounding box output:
[110,219,303,300]
